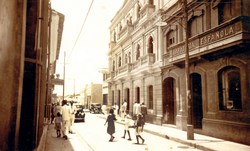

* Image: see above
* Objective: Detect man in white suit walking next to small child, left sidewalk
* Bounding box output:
[62,100,70,139]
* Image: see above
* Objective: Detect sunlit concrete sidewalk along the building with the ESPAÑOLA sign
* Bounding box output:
[97,114,250,151]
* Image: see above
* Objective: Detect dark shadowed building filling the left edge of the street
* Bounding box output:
[0,0,64,151]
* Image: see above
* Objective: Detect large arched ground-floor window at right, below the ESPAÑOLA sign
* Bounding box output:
[218,66,242,110]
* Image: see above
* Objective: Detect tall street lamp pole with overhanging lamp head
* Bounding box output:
[156,0,194,140]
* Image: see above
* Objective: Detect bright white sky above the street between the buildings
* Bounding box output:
[51,0,124,95]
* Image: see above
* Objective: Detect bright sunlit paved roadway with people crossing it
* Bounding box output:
[75,113,201,151]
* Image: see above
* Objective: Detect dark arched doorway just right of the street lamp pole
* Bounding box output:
[190,73,203,128]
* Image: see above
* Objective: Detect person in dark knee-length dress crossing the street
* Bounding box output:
[104,109,116,142]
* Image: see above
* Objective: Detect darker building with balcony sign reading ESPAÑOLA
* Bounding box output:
[161,0,250,144]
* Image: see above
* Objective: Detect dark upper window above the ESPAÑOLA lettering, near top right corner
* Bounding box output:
[218,0,237,24]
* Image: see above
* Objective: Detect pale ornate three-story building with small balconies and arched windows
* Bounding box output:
[106,0,162,124]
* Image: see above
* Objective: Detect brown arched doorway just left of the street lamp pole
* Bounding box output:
[162,77,176,125]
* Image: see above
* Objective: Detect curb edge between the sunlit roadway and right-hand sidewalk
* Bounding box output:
[97,115,216,151]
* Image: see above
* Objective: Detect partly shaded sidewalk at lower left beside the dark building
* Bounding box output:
[45,124,93,151]
